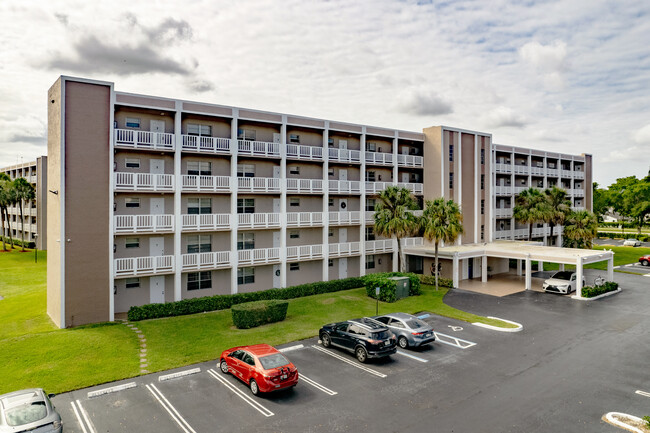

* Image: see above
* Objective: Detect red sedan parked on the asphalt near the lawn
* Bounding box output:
[219,344,298,395]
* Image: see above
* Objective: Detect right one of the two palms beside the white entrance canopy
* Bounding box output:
[420,198,463,290]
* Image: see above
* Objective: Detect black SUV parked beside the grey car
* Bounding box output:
[318,318,397,362]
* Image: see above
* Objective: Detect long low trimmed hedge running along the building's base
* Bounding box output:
[127,277,365,322]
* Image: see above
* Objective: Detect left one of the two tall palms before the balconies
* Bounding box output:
[375,185,418,272]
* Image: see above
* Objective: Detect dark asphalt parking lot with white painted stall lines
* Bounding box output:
[53,268,650,433]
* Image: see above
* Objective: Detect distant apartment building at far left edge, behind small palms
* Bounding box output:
[0,156,47,250]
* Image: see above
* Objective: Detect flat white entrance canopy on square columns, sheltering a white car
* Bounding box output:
[404,241,614,297]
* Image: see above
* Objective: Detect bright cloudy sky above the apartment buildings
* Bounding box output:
[0,0,650,185]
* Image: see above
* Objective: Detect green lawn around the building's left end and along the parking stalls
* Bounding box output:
[0,250,512,394]
